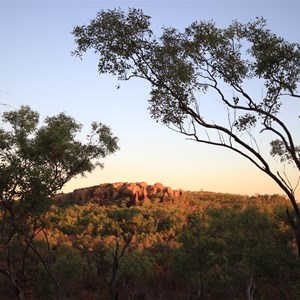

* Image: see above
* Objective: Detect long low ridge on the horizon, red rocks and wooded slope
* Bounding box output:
[53,182,290,210]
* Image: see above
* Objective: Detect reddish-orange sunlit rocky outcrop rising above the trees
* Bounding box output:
[54,182,183,205]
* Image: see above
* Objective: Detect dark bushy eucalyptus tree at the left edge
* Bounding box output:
[0,106,118,299]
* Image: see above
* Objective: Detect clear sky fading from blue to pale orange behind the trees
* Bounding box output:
[0,0,300,198]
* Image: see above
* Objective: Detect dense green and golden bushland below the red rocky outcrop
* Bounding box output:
[0,192,300,299]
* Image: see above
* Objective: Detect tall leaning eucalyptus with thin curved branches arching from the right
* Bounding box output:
[73,9,300,254]
